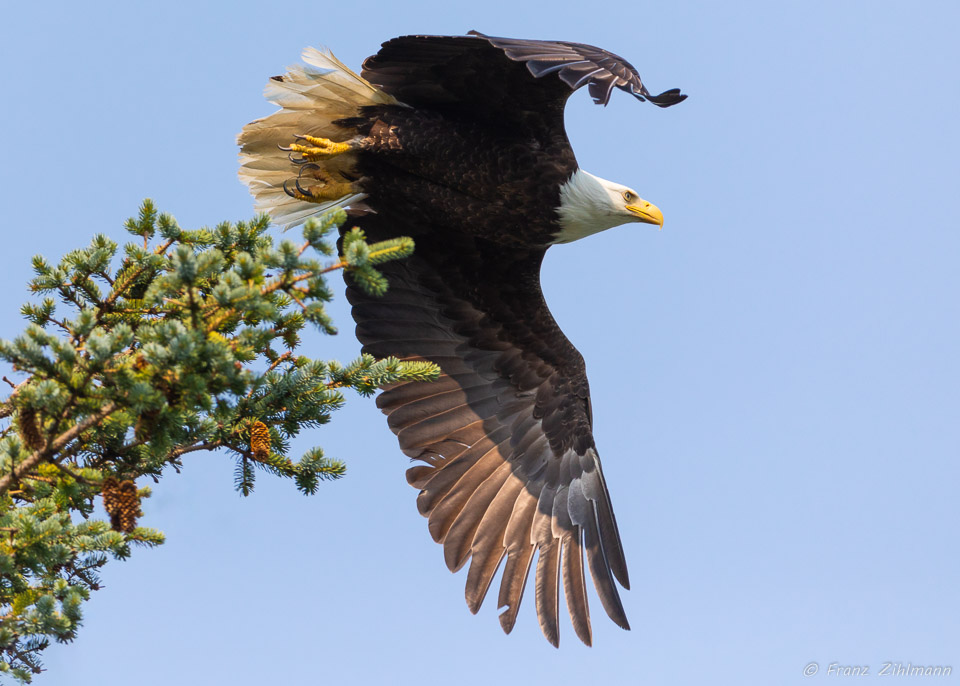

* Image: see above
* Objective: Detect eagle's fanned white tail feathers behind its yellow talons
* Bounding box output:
[237,48,400,229]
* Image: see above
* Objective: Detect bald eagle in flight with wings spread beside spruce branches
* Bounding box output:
[238,32,686,646]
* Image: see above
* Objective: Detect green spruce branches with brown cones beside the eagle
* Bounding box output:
[0,201,439,682]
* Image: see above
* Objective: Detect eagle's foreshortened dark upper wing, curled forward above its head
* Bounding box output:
[363,31,687,126]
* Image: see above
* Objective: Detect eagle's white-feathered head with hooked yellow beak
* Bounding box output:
[553,169,663,243]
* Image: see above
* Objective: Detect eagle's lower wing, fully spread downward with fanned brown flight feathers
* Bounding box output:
[348,214,629,645]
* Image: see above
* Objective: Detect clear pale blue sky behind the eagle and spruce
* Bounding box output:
[0,0,960,686]
